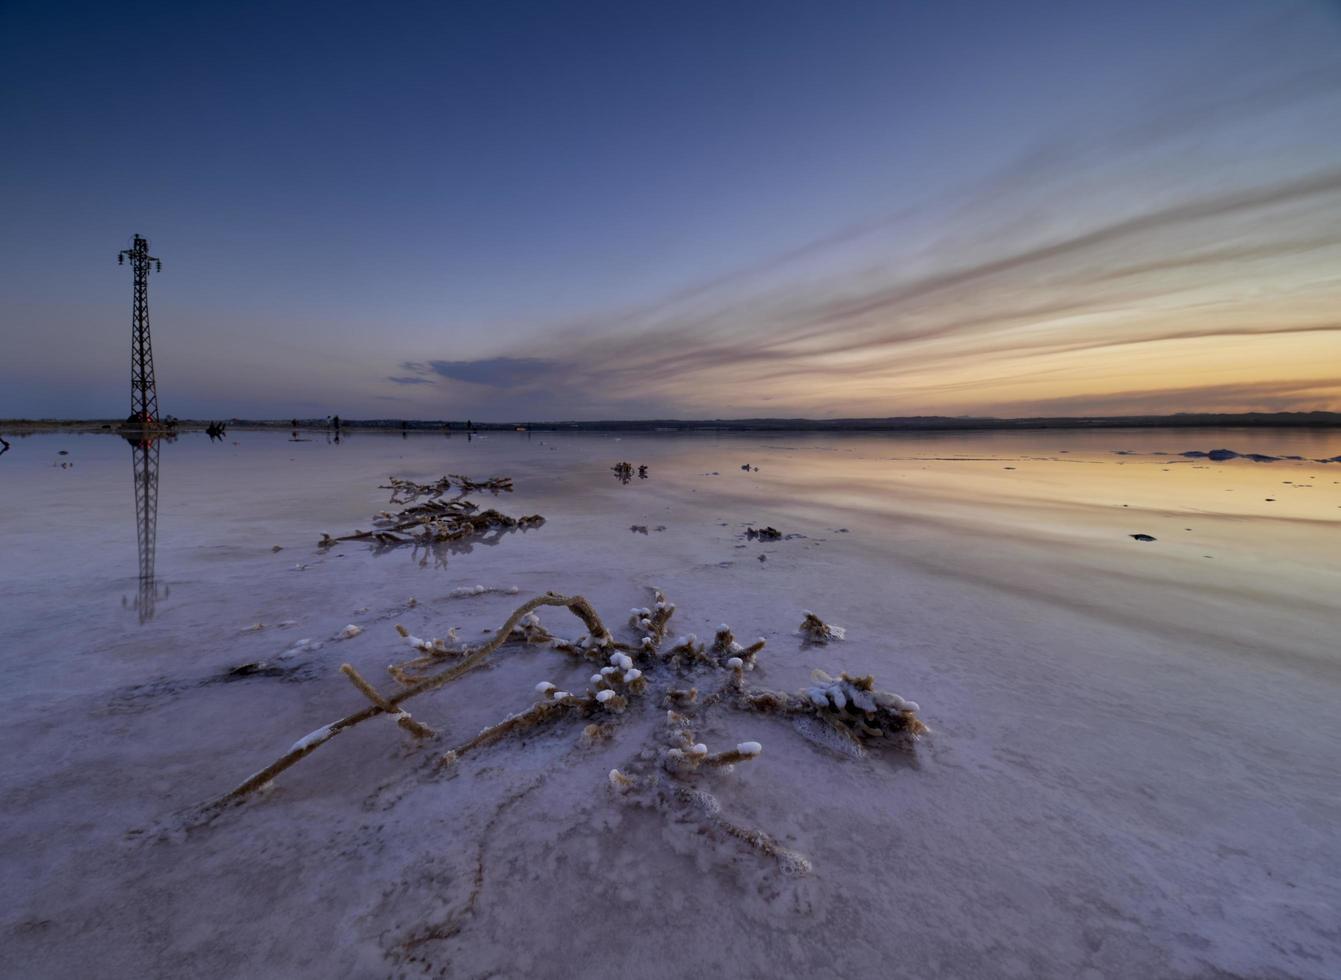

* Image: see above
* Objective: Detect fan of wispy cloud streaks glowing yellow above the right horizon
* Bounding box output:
[399,47,1341,414]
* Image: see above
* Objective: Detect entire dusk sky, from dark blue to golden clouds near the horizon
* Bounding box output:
[0,0,1341,421]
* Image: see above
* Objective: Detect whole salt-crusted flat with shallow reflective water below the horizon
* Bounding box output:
[0,430,1341,977]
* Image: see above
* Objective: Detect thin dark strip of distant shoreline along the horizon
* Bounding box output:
[0,412,1341,433]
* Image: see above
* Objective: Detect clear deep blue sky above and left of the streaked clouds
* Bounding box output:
[0,0,1341,417]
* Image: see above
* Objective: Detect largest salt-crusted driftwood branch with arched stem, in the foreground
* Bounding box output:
[200,581,928,874]
